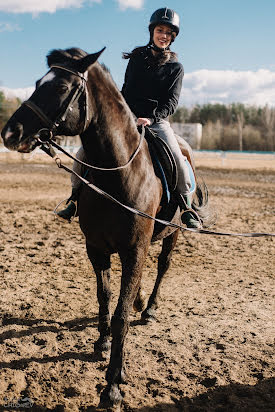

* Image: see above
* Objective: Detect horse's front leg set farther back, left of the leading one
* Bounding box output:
[86,243,111,357]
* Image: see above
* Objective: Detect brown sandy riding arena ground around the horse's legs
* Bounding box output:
[0,154,275,412]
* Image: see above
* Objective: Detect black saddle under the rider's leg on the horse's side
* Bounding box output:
[145,128,178,203]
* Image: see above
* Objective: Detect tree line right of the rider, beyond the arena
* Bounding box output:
[170,103,275,151]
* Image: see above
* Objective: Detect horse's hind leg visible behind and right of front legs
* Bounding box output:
[141,230,179,323]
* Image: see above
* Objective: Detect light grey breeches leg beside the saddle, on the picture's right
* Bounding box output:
[149,120,192,195]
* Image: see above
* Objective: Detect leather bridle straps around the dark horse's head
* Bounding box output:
[22,65,89,143]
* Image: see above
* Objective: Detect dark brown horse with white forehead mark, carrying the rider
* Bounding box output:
[1,48,211,410]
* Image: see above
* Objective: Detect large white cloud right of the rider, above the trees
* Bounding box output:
[180,69,275,106]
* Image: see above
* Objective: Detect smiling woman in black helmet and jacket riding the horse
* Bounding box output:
[58,7,200,228]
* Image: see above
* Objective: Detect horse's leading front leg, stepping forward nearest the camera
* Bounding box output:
[101,245,149,410]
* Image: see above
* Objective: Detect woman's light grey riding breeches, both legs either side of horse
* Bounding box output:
[71,120,194,195]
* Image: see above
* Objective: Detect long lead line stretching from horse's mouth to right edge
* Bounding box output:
[41,142,275,237]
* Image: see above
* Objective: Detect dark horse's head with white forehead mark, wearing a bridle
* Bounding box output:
[1,48,104,153]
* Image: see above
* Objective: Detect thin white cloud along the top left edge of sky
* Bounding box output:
[0,0,101,14]
